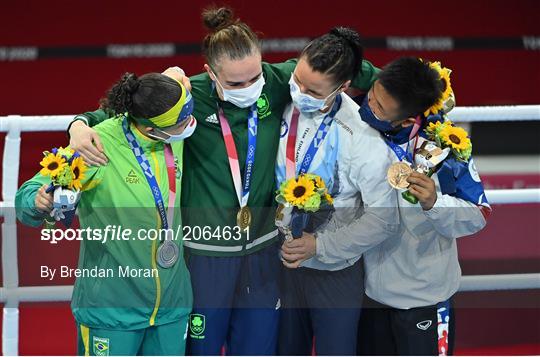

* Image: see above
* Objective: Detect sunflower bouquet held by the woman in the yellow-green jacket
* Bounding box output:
[39,147,87,226]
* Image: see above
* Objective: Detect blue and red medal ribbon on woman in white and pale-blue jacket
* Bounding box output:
[285,95,341,179]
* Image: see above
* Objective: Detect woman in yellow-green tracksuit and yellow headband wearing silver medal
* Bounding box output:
[16,73,196,356]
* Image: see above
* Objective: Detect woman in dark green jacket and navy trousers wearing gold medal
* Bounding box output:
[66,8,377,355]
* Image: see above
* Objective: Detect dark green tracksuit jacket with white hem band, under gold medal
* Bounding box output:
[71,60,378,256]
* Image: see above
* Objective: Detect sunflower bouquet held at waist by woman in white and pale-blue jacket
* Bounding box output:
[276,174,334,239]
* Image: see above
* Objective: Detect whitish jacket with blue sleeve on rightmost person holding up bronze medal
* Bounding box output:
[364,138,491,309]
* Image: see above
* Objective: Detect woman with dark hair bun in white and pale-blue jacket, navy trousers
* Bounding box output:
[276,28,398,355]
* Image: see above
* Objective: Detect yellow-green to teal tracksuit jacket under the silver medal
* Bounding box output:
[15,118,192,330]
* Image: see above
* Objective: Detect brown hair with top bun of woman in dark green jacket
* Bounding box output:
[202,7,261,68]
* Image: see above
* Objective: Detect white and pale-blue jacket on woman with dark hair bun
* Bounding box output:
[276,94,399,270]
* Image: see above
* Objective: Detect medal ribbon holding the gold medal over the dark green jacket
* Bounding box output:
[219,104,259,208]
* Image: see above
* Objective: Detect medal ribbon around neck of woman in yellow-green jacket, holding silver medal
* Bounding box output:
[122,118,176,234]
